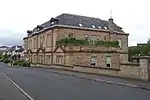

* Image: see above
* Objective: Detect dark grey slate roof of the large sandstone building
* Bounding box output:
[30,13,123,34]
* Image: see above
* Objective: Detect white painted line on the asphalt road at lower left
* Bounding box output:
[1,73,34,100]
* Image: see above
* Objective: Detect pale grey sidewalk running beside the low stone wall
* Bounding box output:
[46,67,150,90]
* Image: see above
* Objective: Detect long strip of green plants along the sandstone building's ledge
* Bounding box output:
[56,38,119,47]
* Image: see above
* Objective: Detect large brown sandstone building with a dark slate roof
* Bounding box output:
[24,14,129,69]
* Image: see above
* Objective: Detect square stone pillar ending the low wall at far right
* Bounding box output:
[139,56,150,81]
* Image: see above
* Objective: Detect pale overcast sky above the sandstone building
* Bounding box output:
[0,0,150,46]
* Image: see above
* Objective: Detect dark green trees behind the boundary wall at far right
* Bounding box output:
[128,40,150,61]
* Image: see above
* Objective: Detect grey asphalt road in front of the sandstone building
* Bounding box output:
[0,64,150,100]
